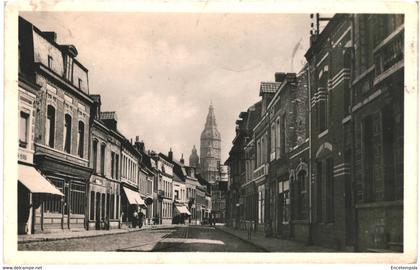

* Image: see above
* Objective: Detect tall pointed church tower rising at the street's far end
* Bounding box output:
[200,104,221,183]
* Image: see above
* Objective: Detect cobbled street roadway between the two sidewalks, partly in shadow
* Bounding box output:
[18,226,260,252]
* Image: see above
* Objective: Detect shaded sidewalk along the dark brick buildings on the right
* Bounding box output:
[216,226,338,252]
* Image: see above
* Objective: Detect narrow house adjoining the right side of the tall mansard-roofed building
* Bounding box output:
[88,98,124,230]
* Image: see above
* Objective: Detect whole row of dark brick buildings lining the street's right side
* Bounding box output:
[226,14,404,251]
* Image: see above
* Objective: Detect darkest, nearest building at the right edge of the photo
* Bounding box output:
[352,14,404,251]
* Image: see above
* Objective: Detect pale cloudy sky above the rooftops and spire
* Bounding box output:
[21,12,310,162]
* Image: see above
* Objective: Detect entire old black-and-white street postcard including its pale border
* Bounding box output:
[3,0,418,263]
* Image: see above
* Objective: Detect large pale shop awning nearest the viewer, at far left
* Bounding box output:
[18,164,64,196]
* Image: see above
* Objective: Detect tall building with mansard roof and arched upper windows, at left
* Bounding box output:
[19,17,93,230]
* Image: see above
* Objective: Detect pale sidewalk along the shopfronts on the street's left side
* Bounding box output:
[18,224,183,244]
